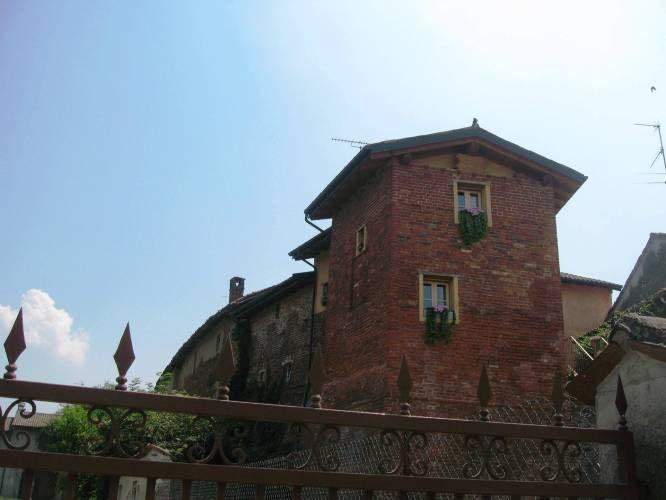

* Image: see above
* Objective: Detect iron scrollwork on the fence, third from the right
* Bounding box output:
[379,429,428,476]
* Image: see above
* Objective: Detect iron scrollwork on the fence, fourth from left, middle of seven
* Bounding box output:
[287,423,340,472]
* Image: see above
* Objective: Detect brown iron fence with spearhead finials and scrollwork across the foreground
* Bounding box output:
[0,312,638,500]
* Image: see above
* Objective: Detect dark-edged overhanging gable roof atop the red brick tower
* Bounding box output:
[305,125,587,219]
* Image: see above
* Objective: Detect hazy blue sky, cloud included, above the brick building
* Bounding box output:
[0,0,666,394]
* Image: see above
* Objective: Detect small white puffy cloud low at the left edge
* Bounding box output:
[0,288,89,366]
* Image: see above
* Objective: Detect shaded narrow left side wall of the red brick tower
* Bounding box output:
[323,169,392,410]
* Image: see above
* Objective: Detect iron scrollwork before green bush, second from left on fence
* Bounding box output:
[86,406,148,458]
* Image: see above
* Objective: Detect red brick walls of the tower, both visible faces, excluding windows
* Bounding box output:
[326,156,563,416]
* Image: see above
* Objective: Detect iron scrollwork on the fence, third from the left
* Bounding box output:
[186,416,249,465]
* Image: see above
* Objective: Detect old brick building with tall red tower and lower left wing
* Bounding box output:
[167,122,615,415]
